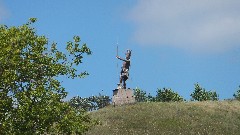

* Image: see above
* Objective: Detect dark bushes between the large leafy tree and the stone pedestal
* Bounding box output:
[69,94,110,111]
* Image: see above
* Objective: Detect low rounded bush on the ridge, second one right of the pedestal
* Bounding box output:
[156,88,183,102]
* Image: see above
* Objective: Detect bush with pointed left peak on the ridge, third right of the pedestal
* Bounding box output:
[191,83,218,101]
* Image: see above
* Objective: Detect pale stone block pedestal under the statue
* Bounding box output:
[112,88,135,105]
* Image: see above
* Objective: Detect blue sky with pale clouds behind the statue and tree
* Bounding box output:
[0,0,240,99]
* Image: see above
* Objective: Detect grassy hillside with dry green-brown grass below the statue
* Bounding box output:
[87,101,240,135]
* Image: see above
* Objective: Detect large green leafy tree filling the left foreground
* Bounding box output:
[0,18,93,134]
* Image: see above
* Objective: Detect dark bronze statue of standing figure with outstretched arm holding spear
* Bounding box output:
[116,50,131,89]
